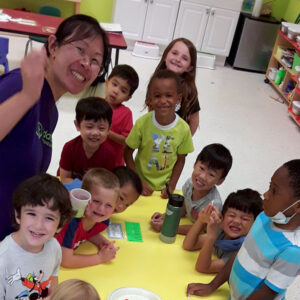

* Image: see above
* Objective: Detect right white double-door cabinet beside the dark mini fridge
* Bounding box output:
[174,0,242,56]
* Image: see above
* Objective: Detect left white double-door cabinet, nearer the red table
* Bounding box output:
[114,0,180,45]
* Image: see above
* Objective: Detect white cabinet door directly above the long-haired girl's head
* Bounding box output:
[174,1,210,51]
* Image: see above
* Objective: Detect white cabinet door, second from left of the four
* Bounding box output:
[143,0,179,45]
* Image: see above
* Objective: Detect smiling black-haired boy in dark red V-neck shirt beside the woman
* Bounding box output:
[57,97,117,183]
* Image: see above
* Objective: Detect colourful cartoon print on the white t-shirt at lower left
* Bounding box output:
[6,267,52,300]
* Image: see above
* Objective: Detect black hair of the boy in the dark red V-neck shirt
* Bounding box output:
[75,97,113,126]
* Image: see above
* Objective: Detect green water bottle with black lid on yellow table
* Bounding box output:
[159,189,184,244]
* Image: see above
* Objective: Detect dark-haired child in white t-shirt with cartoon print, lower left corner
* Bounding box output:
[0,174,73,299]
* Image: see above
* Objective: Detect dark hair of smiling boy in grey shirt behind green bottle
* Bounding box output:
[196,144,232,178]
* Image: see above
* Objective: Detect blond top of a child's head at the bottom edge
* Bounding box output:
[49,279,100,300]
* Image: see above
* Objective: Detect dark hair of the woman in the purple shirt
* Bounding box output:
[45,14,110,76]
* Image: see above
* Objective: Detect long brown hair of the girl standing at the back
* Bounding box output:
[145,38,198,123]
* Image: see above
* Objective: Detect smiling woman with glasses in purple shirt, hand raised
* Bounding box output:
[0,15,108,241]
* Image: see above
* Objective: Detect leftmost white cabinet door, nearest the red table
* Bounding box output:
[113,0,149,40]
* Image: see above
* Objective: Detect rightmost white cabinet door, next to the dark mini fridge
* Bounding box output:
[201,8,240,56]
